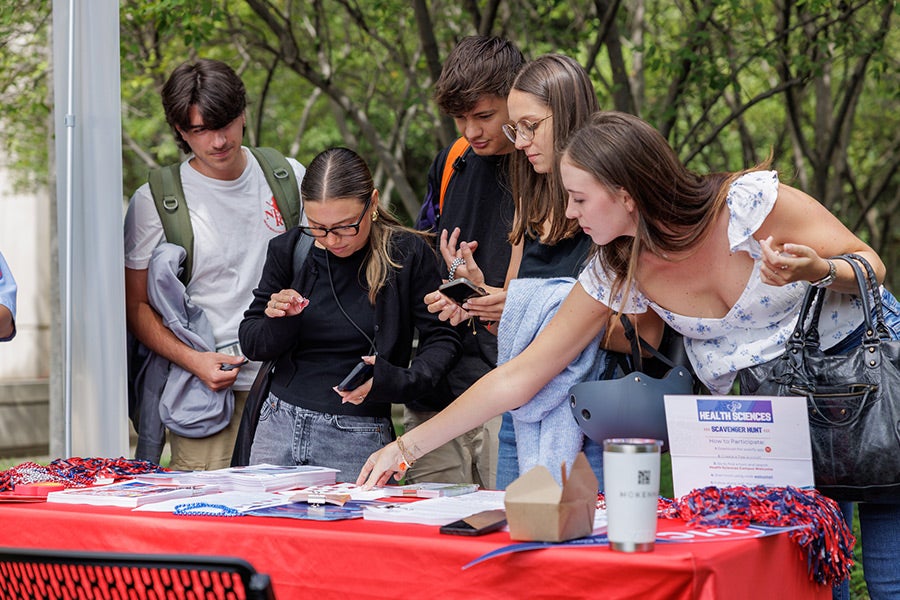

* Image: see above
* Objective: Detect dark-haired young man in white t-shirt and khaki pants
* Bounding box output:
[125,59,305,470]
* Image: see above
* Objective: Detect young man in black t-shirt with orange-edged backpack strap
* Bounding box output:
[404,36,525,488]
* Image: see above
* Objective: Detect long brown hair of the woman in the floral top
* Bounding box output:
[561,111,770,330]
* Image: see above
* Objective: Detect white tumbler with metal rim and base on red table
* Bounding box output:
[603,438,662,552]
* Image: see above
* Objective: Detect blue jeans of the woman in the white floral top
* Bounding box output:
[829,290,900,600]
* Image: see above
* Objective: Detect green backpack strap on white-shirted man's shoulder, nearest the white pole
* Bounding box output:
[147,163,194,286]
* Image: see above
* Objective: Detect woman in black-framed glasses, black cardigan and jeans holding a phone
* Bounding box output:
[240,148,459,481]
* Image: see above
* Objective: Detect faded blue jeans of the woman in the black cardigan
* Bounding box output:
[250,394,393,482]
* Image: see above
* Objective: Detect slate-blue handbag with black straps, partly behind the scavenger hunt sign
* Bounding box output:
[569,315,699,451]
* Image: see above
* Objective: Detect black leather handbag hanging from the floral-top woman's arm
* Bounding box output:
[738,254,900,503]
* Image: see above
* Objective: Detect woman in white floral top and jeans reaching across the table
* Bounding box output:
[359,112,900,598]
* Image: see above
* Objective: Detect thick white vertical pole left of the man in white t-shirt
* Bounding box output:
[53,0,128,457]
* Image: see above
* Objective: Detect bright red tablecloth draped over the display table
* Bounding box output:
[0,503,831,600]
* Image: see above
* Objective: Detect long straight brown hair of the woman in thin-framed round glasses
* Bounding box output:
[509,54,600,245]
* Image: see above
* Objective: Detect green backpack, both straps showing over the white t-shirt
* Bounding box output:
[148,148,300,285]
